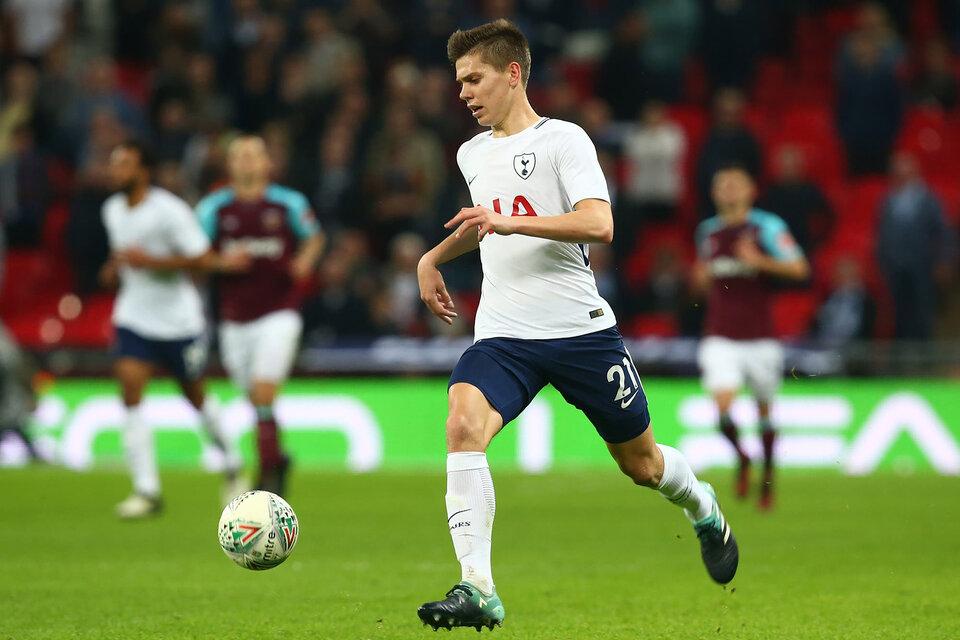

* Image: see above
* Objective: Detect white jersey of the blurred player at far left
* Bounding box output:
[103,187,210,340]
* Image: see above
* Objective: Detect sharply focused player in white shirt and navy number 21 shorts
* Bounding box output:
[418,20,739,631]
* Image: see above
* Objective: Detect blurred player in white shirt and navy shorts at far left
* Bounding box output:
[100,141,249,518]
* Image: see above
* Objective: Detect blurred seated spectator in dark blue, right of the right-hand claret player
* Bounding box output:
[811,256,877,349]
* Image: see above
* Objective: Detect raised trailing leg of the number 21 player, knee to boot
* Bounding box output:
[607,429,740,584]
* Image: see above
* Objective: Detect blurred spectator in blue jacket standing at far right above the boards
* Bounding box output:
[877,153,957,340]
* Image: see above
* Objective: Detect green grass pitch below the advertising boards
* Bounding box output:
[0,463,960,640]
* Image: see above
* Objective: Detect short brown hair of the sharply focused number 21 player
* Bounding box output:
[447,18,530,88]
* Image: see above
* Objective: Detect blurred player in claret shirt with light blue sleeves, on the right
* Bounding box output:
[693,165,810,509]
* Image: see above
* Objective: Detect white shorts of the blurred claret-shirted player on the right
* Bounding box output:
[697,336,783,401]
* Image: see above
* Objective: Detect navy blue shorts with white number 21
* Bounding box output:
[448,327,650,443]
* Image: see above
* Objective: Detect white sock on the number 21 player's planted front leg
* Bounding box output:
[446,451,497,595]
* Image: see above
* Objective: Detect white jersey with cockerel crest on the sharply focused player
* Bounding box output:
[457,118,616,340]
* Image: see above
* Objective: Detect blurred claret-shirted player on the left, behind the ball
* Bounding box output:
[197,136,324,495]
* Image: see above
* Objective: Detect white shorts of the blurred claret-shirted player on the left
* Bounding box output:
[220,309,303,391]
